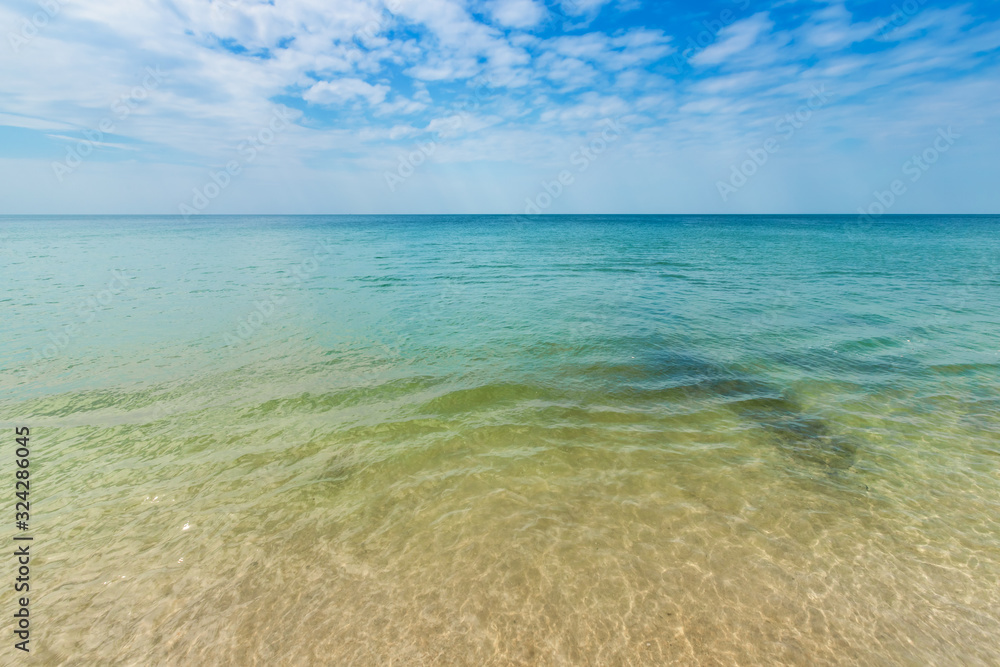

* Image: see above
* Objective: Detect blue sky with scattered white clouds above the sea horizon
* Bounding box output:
[0,0,1000,217]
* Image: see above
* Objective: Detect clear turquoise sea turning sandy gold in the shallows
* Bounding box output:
[0,216,1000,665]
